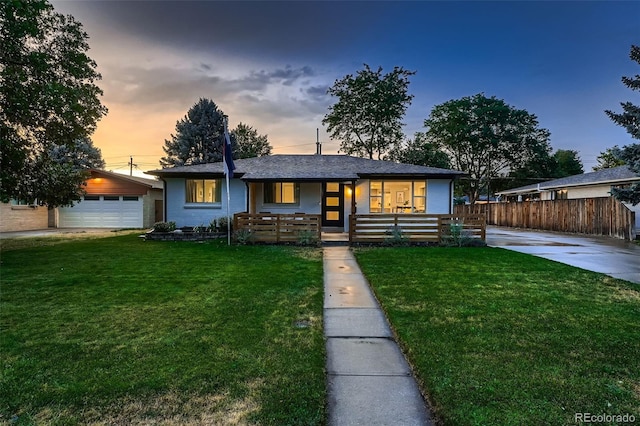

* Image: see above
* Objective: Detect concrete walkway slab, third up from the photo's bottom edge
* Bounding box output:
[324,308,392,338]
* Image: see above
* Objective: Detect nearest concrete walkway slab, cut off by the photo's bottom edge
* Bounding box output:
[327,376,432,426]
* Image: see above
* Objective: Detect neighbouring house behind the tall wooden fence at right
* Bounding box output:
[497,166,640,229]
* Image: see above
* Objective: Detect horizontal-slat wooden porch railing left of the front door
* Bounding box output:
[233,213,321,243]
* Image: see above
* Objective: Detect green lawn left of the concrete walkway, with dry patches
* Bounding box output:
[0,234,325,425]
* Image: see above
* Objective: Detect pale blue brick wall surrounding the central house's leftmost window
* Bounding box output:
[165,178,247,228]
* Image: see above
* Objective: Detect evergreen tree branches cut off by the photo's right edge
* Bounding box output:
[605,45,640,206]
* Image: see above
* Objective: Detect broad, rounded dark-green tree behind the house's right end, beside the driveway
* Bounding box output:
[424,93,550,203]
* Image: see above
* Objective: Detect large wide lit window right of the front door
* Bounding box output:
[369,180,427,213]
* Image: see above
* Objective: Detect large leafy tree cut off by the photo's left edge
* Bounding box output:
[0,0,107,207]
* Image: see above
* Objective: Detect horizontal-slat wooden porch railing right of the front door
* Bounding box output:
[349,214,486,243]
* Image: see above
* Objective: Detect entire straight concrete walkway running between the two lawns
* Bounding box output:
[324,246,431,426]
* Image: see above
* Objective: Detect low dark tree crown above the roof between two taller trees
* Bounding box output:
[385,132,451,169]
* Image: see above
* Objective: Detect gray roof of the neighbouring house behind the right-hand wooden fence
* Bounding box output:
[498,166,640,195]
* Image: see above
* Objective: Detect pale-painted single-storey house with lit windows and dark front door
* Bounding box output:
[147,154,463,230]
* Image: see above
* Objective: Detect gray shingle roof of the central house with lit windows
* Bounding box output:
[146,155,464,181]
